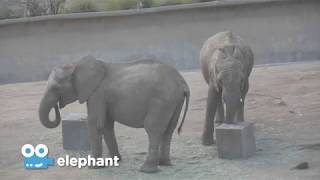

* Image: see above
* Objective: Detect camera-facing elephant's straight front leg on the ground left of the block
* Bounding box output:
[202,84,218,145]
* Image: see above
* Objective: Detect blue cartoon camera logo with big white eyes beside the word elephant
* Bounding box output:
[21,144,54,169]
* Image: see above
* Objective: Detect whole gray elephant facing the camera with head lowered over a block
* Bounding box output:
[200,31,254,145]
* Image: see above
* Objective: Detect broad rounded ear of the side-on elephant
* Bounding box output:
[74,56,105,104]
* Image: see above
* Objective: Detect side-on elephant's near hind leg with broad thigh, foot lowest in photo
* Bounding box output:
[140,99,174,173]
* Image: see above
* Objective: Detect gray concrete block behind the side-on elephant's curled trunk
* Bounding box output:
[62,113,90,151]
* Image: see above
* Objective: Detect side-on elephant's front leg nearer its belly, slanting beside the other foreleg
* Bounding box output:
[103,121,121,160]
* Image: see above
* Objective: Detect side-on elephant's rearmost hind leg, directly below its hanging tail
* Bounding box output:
[159,101,183,166]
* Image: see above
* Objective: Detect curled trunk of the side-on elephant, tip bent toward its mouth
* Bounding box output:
[39,90,61,128]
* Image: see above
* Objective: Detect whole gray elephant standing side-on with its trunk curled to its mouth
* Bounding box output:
[39,56,190,173]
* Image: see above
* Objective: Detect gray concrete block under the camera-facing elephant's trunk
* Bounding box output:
[216,122,256,159]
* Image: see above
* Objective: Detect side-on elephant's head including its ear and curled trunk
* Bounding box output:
[39,56,105,128]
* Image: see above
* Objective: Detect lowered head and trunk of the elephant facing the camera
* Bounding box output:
[215,46,247,123]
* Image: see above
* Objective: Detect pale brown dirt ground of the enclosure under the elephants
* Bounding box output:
[0,63,320,180]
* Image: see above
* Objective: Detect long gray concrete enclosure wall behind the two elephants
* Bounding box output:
[0,0,320,83]
